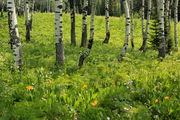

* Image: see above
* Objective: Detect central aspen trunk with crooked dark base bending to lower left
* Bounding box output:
[79,0,96,67]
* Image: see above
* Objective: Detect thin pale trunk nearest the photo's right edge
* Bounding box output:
[174,0,179,51]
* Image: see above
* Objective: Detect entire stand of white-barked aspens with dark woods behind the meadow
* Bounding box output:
[1,0,179,68]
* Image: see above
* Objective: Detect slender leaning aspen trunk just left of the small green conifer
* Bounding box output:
[139,0,152,52]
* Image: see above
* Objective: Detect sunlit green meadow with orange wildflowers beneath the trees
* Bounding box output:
[0,13,180,120]
